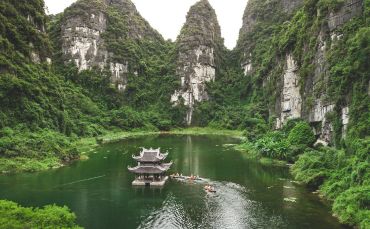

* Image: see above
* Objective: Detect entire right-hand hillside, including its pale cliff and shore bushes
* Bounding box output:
[236,0,370,228]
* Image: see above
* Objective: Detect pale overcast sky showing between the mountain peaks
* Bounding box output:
[45,0,248,49]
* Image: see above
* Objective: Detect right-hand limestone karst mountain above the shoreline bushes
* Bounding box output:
[238,0,363,144]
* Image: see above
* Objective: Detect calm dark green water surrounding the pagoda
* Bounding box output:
[0,135,343,229]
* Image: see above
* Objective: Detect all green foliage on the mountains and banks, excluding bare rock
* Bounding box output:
[0,0,370,228]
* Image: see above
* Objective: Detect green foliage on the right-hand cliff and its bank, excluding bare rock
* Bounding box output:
[238,0,370,228]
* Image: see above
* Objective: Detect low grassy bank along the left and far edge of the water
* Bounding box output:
[0,127,246,174]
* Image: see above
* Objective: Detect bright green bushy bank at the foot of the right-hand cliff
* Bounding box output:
[235,122,370,228]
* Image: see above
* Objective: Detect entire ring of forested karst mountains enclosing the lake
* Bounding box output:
[0,0,370,228]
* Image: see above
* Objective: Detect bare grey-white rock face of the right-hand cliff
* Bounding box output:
[238,0,363,144]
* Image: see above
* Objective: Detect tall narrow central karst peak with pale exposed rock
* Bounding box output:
[171,0,223,125]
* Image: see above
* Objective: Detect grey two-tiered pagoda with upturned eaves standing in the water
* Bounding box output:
[128,148,172,186]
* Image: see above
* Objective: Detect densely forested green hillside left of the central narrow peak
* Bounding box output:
[0,1,184,172]
